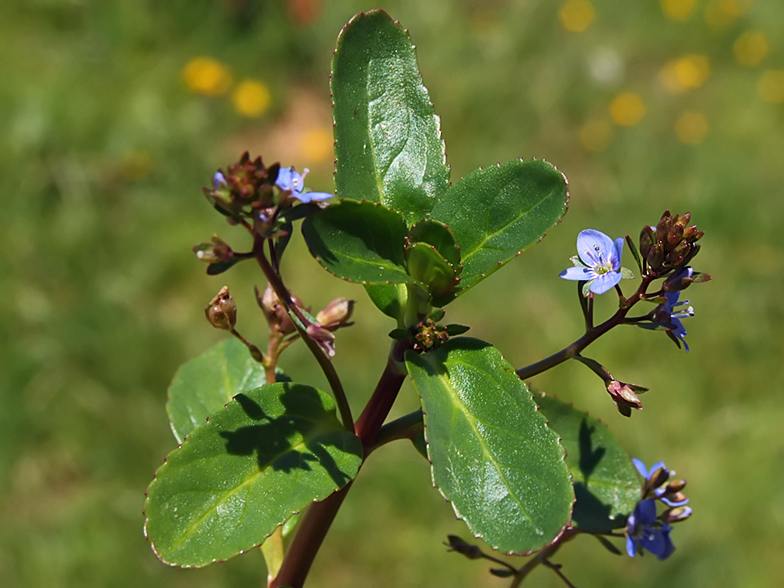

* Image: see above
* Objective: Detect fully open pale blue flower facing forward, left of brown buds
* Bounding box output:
[560,229,623,294]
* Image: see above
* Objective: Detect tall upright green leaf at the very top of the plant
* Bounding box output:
[331,10,449,224]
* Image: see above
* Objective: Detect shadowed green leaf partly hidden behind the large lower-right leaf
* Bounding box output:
[534,392,640,533]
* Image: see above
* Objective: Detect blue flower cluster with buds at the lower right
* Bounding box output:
[626,458,692,559]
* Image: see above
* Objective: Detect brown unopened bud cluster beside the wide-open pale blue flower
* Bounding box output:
[640,210,705,276]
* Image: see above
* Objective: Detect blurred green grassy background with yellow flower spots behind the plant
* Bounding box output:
[0,0,784,588]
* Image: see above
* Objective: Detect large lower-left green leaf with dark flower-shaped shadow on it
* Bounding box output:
[145,383,363,567]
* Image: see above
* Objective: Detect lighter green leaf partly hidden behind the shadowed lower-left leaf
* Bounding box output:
[166,338,267,443]
